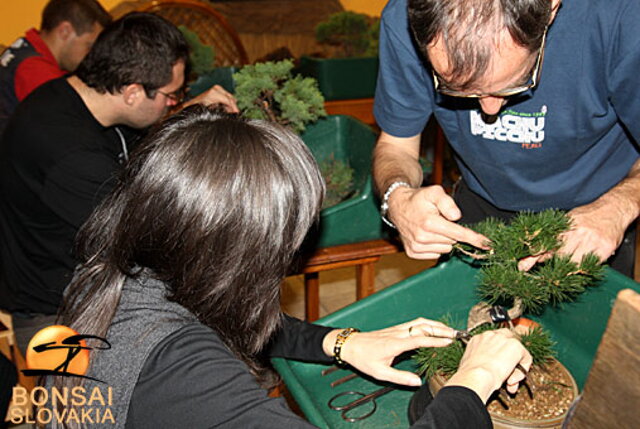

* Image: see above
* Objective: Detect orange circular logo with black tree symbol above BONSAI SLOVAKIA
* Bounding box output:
[26,325,89,375]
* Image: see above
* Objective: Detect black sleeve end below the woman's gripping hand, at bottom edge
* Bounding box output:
[411,386,493,429]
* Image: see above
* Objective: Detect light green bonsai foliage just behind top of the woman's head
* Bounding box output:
[233,60,327,133]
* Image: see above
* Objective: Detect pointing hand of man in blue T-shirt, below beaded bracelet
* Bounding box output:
[388,185,489,259]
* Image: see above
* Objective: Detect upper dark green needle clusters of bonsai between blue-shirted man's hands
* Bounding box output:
[456,210,603,313]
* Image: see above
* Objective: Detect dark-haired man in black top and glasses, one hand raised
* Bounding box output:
[0,13,237,350]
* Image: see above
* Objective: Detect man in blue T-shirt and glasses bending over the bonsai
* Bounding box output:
[374,0,640,276]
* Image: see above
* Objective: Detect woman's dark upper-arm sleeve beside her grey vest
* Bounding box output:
[126,324,313,429]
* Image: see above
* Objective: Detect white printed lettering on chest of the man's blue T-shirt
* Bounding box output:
[469,106,547,149]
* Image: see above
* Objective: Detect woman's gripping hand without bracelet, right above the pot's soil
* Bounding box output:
[447,329,532,403]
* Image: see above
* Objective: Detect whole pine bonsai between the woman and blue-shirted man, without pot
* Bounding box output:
[414,210,604,377]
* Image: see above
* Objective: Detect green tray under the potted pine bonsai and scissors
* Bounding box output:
[273,258,640,428]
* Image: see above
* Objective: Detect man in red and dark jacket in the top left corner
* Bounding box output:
[0,0,111,133]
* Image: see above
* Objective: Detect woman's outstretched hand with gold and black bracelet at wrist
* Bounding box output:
[322,318,456,386]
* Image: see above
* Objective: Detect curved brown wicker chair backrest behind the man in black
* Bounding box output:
[136,0,249,67]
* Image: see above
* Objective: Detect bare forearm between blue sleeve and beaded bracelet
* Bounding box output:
[373,136,422,194]
